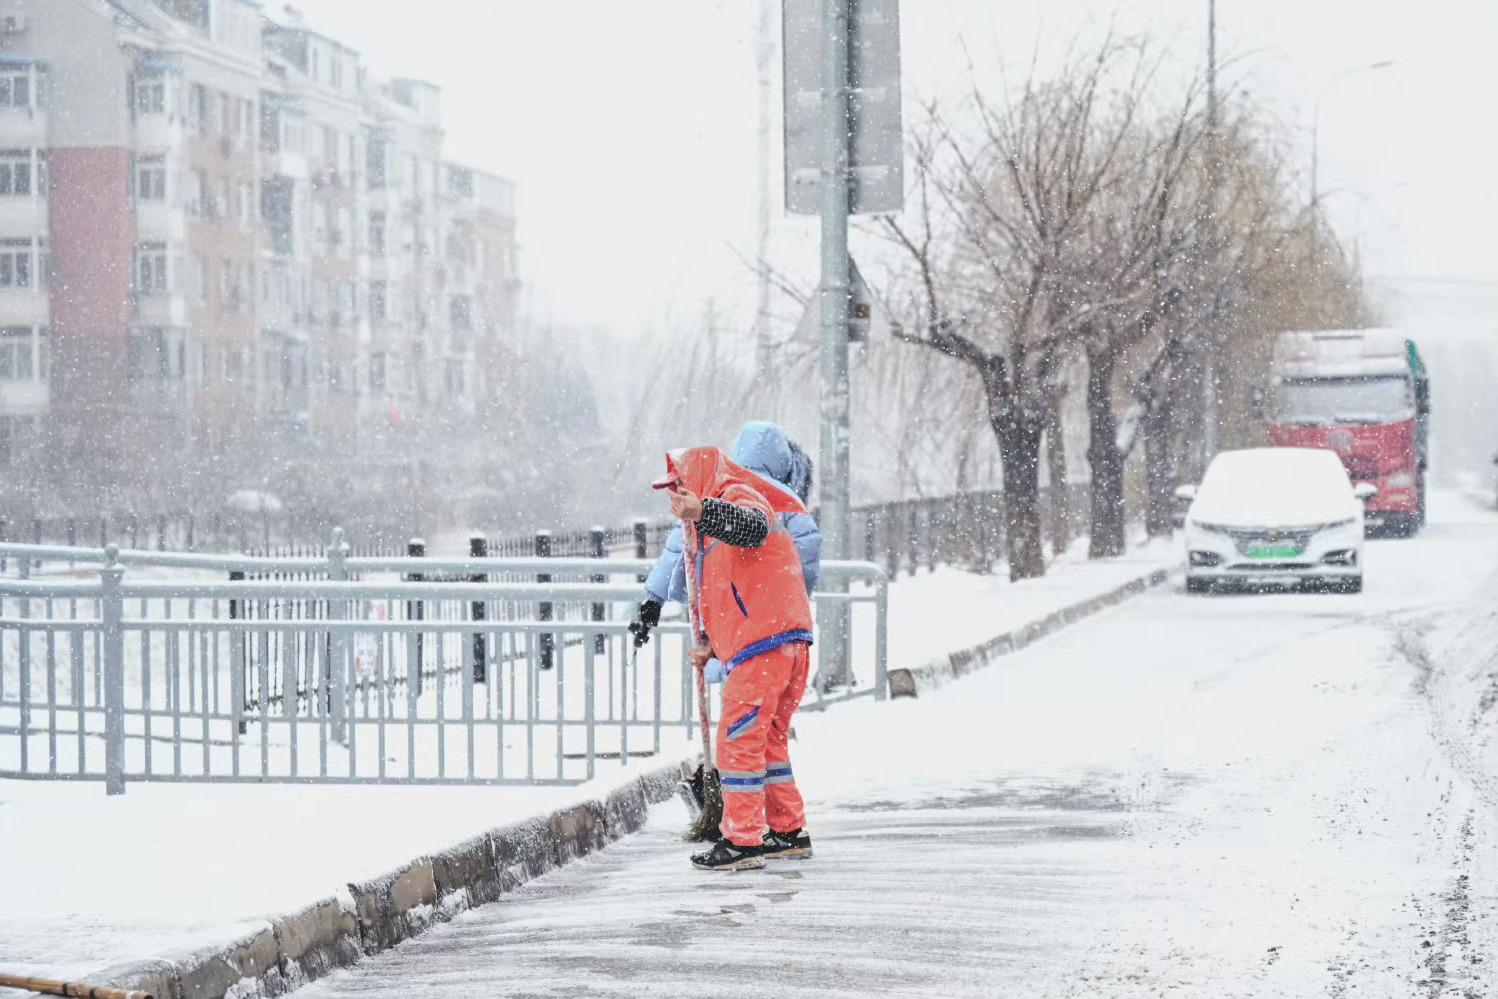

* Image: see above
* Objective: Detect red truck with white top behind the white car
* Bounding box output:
[1263,330,1431,538]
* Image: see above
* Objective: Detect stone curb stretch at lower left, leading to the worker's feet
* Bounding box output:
[73,761,689,999]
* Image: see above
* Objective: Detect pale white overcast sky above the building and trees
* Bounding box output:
[292,0,1498,335]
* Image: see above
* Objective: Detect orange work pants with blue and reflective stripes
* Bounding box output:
[718,641,810,846]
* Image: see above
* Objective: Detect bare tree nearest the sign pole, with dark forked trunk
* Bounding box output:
[882,40,1131,580]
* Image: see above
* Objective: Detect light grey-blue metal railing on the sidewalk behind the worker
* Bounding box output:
[0,535,888,794]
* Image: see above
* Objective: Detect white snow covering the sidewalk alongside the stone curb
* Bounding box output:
[0,545,1179,977]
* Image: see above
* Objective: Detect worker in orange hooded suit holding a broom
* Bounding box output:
[655,448,812,870]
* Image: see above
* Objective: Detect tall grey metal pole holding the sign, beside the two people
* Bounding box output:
[816,0,849,690]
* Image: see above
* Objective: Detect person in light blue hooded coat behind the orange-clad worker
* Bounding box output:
[629,419,822,665]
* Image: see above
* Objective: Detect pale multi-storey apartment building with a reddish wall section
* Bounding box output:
[0,0,517,458]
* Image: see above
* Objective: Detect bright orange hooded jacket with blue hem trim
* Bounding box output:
[667,448,812,671]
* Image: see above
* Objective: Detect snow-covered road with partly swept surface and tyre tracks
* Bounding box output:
[300,499,1498,999]
